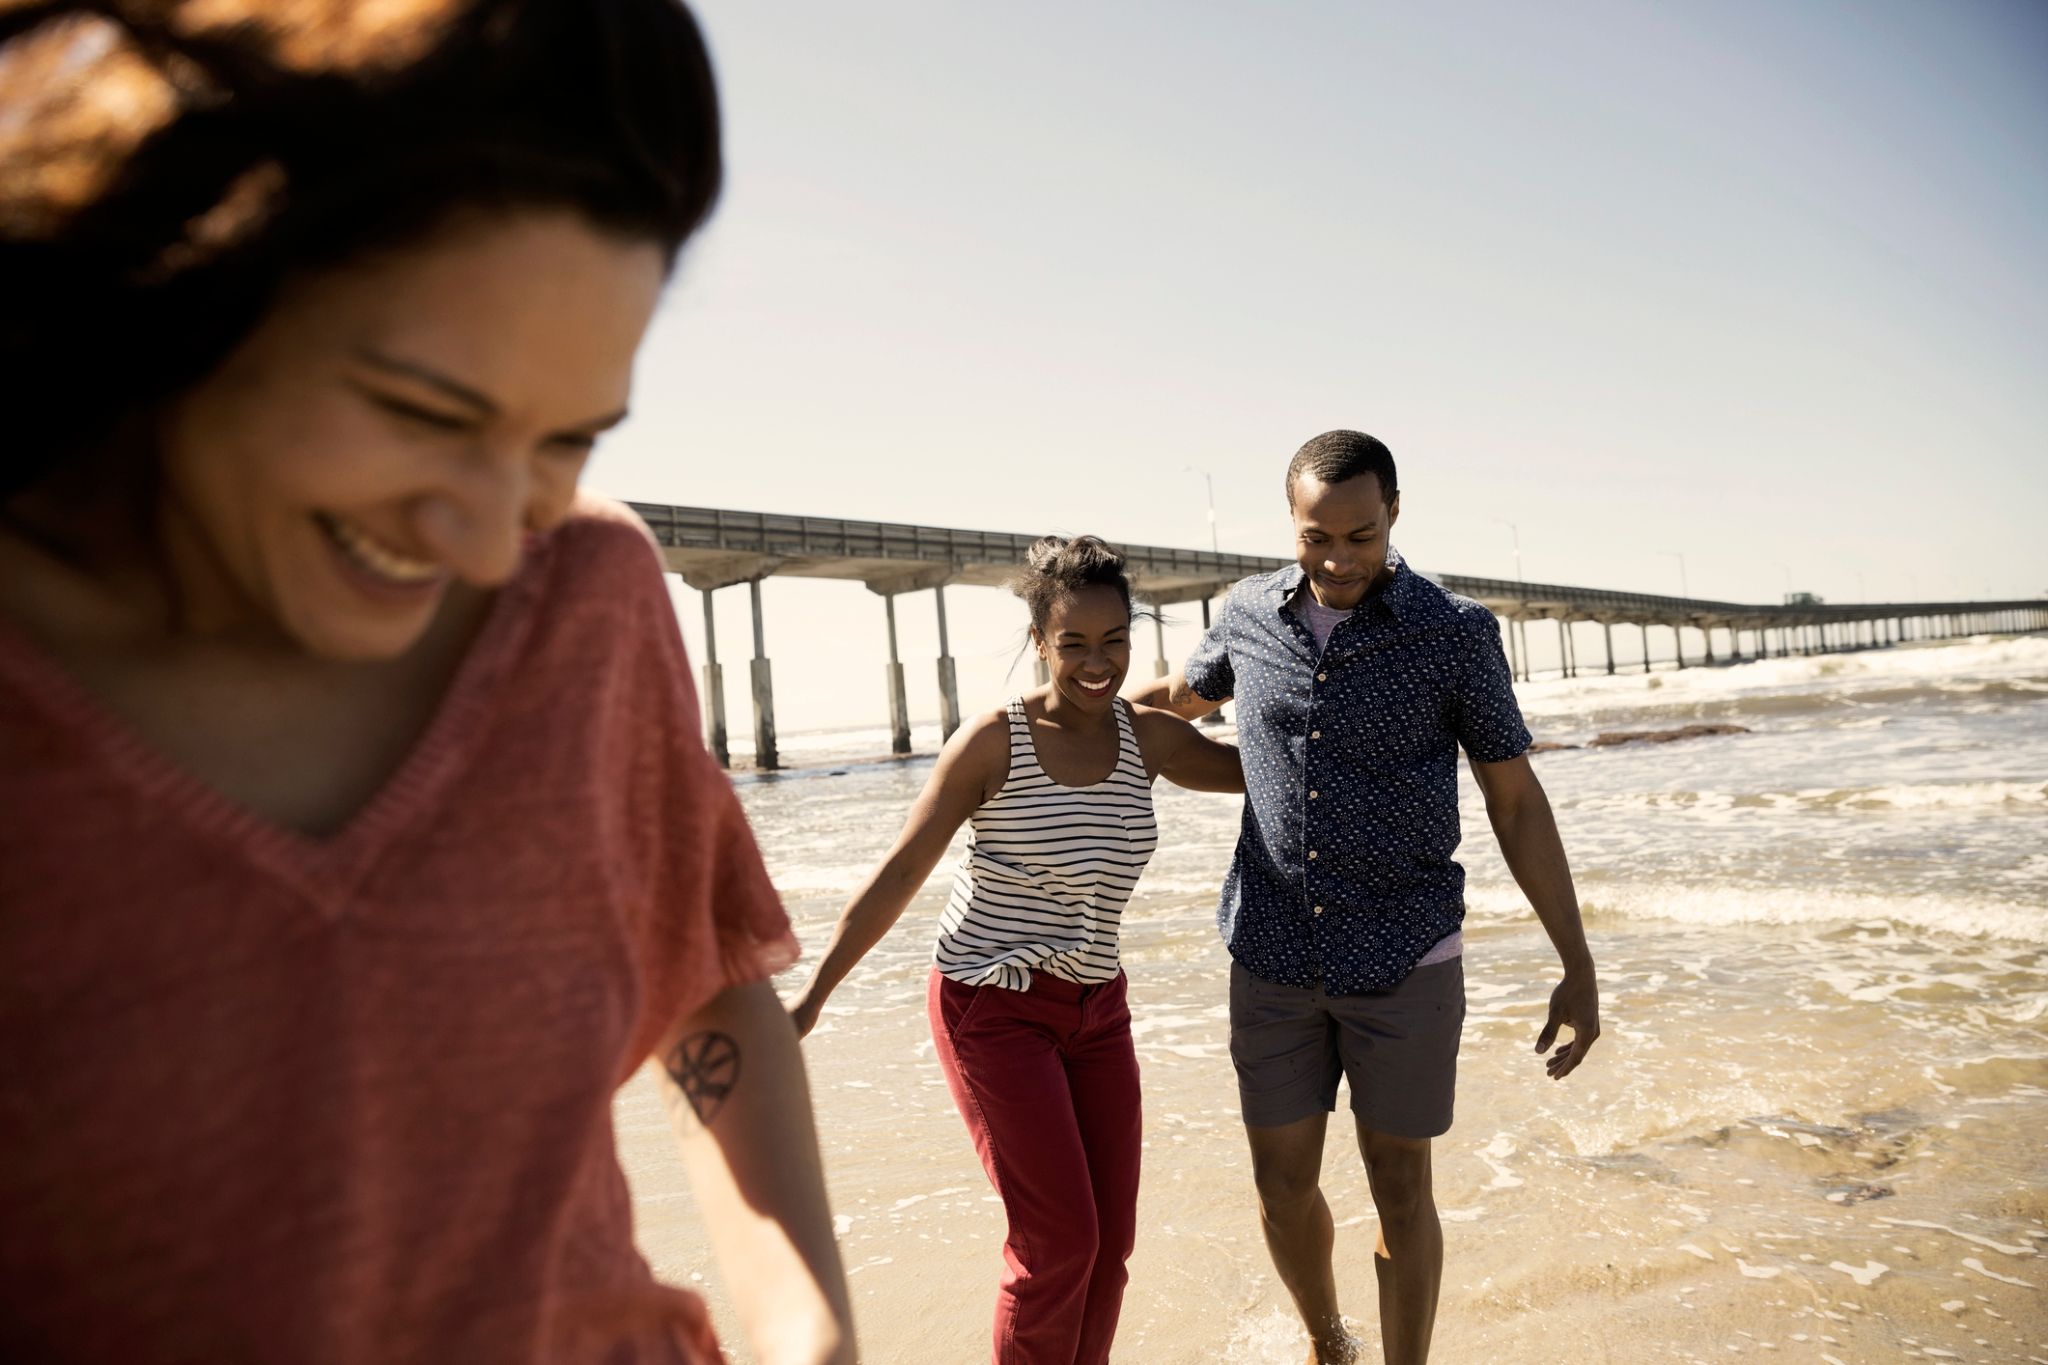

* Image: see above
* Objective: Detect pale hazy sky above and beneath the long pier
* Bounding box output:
[592,0,2048,729]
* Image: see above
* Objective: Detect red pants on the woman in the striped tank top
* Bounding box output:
[928,970,1143,1365]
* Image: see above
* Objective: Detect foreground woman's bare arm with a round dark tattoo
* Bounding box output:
[655,980,856,1365]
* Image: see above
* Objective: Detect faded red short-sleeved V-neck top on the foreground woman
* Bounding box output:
[0,505,797,1365]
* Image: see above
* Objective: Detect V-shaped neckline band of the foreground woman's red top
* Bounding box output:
[0,536,549,923]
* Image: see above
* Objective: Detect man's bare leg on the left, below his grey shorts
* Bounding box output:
[1245,1113,1354,1365]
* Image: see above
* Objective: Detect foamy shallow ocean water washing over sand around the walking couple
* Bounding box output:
[618,636,2048,1365]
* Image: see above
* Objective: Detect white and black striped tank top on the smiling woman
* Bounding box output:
[932,696,1159,990]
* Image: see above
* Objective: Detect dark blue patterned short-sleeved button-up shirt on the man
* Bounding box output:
[1184,551,1530,995]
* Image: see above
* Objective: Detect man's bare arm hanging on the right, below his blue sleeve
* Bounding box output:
[1473,753,1599,1081]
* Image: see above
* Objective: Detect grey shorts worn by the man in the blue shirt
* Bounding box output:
[1231,958,1464,1138]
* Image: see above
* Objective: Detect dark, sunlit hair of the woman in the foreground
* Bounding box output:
[0,0,723,499]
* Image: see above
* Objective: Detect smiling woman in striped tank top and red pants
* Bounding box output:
[791,536,1245,1365]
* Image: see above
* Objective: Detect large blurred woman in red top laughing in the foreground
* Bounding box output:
[0,0,852,1363]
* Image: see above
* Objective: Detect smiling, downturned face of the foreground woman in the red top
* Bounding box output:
[162,211,664,659]
